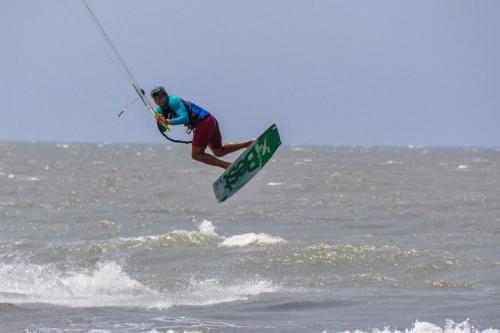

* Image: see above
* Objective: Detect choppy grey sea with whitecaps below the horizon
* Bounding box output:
[0,143,500,333]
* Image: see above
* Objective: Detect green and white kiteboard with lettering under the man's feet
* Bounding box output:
[214,124,281,202]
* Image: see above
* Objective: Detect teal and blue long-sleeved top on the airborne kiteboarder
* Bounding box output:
[156,95,210,126]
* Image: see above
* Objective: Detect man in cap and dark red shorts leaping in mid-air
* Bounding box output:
[151,86,255,169]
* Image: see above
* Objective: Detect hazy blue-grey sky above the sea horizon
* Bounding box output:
[0,0,500,146]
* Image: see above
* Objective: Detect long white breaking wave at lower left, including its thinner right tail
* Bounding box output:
[0,262,280,308]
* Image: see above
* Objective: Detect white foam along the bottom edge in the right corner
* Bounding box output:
[343,320,499,333]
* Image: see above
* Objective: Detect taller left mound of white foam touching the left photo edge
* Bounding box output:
[0,262,159,307]
